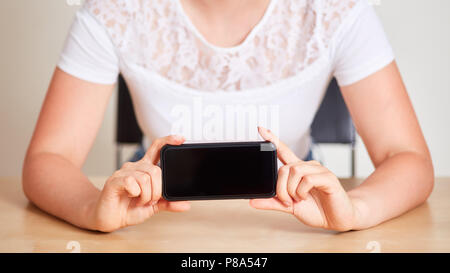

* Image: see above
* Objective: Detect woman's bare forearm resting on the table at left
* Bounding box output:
[23,153,100,229]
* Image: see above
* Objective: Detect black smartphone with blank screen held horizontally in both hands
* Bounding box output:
[160,141,278,201]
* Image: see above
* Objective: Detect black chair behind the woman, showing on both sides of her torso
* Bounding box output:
[116,75,356,176]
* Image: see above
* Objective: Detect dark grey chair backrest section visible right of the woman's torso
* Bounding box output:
[311,78,356,144]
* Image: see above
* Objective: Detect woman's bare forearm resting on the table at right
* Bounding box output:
[348,152,434,229]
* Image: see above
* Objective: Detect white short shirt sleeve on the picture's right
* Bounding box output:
[332,0,394,86]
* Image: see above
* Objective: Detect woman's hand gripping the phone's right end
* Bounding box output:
[250,127,358,231]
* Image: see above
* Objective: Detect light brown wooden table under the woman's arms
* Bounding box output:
[0,178,450,252]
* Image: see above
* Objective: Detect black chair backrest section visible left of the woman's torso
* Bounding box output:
[116,75,142,144]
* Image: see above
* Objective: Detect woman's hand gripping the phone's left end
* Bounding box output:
[91,136,190,232]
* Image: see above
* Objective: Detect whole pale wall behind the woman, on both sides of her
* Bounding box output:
[0,0,450,176]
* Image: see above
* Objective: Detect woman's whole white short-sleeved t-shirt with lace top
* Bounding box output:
[58,0,394,157]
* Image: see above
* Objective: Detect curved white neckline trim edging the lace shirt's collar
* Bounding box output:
[175,0,276,52]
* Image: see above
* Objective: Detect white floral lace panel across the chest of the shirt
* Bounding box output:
[85,0,357,91]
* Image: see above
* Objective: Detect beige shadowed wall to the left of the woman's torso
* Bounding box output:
[0,0,116,176]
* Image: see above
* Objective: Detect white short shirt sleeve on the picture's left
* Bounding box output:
[58,7,119,84]
